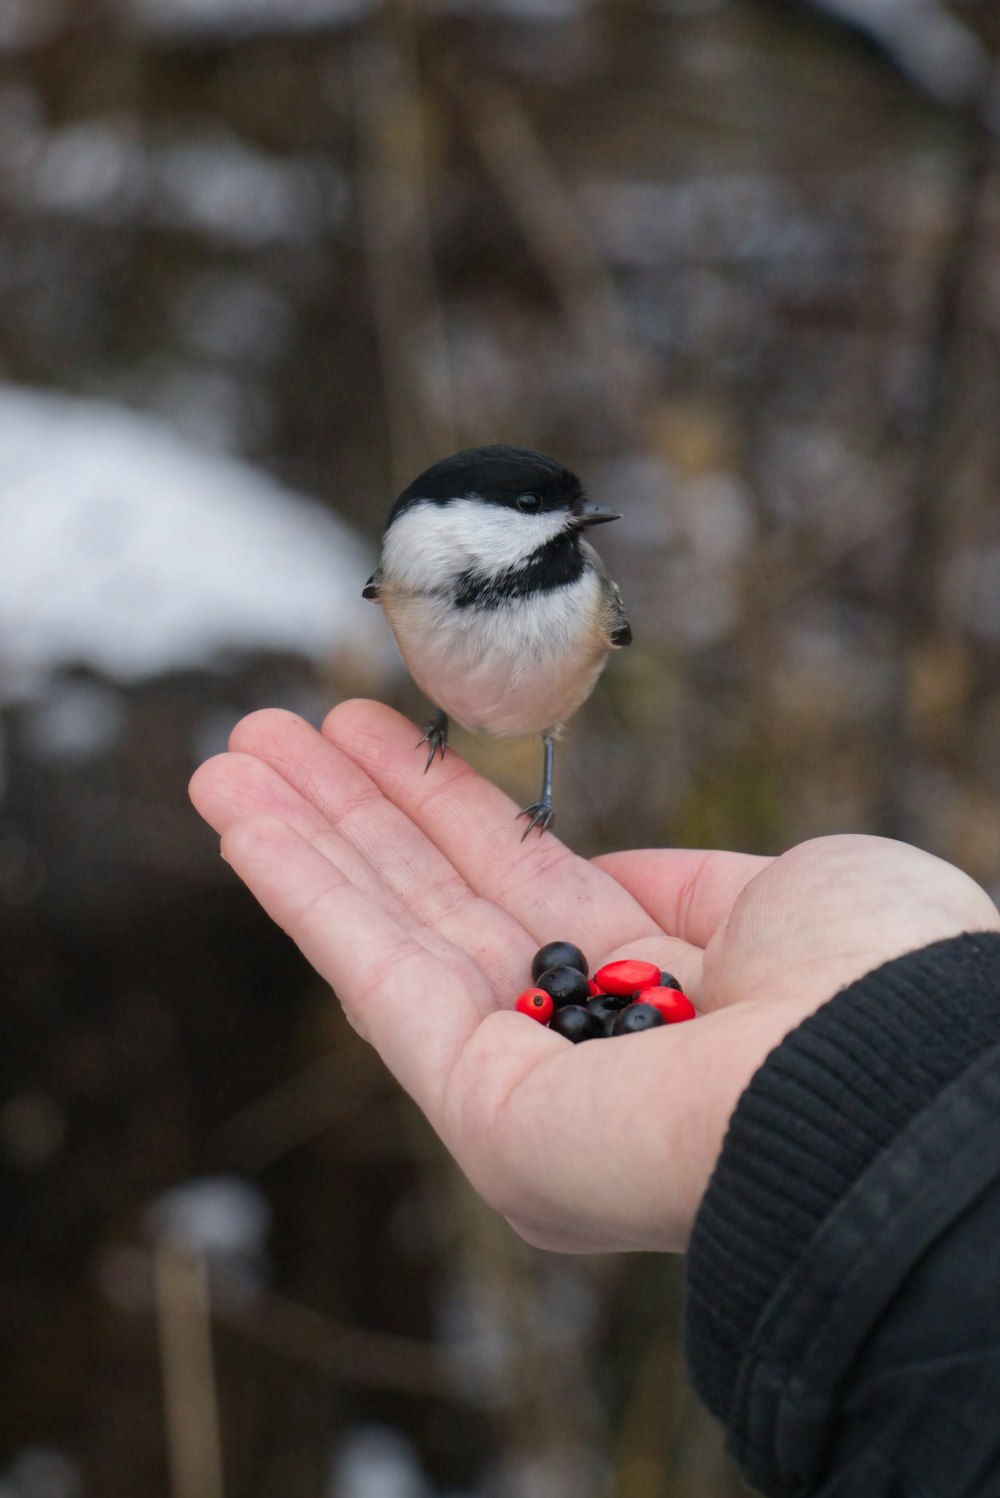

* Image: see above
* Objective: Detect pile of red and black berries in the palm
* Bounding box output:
[513,941,695,1043]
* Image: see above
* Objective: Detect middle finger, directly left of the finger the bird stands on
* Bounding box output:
[229,709,534,1002]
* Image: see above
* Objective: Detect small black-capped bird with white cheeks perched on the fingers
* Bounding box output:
[362,445,632,840]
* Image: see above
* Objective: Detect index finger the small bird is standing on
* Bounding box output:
[323,701,659,960]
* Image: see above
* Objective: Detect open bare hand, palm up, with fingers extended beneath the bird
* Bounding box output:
[192,701,1000,1252]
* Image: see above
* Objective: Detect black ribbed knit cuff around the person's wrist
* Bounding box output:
[684,933,1000,1422]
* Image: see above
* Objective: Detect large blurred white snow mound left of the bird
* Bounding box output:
[0,386,391,701]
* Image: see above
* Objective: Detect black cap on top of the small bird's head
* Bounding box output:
[386,443,584,526]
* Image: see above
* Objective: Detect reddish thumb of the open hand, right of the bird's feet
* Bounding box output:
[593,848,774,950]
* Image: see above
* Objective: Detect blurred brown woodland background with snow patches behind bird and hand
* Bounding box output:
[0,0,1000,1498]
